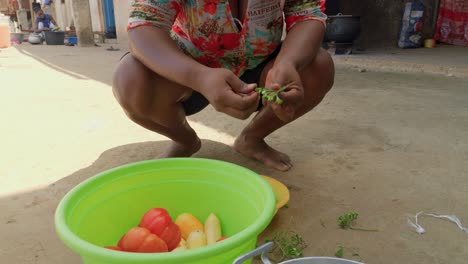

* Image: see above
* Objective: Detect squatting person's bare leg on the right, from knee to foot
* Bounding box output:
[234,49,335,171]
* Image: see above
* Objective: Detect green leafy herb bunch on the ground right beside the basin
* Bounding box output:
[266,230,307,262]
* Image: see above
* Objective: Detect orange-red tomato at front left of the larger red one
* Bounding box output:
[119,227,168,253]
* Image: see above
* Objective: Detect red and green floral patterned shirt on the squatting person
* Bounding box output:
[127,0,326,75]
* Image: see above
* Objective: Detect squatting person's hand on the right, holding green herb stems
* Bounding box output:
[263,63,304,122]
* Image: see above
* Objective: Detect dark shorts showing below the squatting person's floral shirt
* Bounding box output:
[122,45,281,116]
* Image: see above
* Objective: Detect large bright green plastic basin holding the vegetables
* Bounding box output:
[55,158,275,264]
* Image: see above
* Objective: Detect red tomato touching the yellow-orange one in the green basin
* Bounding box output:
[139,208,181,251]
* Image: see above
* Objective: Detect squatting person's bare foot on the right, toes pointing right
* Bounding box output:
[234,136,292,171]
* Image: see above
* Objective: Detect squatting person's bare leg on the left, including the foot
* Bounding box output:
[113,55,201,158]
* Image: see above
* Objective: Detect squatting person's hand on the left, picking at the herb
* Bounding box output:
[196,68,260,119]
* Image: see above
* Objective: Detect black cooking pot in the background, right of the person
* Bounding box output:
[324,14,361,43]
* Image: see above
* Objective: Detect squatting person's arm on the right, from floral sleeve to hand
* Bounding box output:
[265,0,326,122]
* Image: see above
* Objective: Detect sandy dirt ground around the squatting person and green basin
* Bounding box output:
[0,42,468,264]
